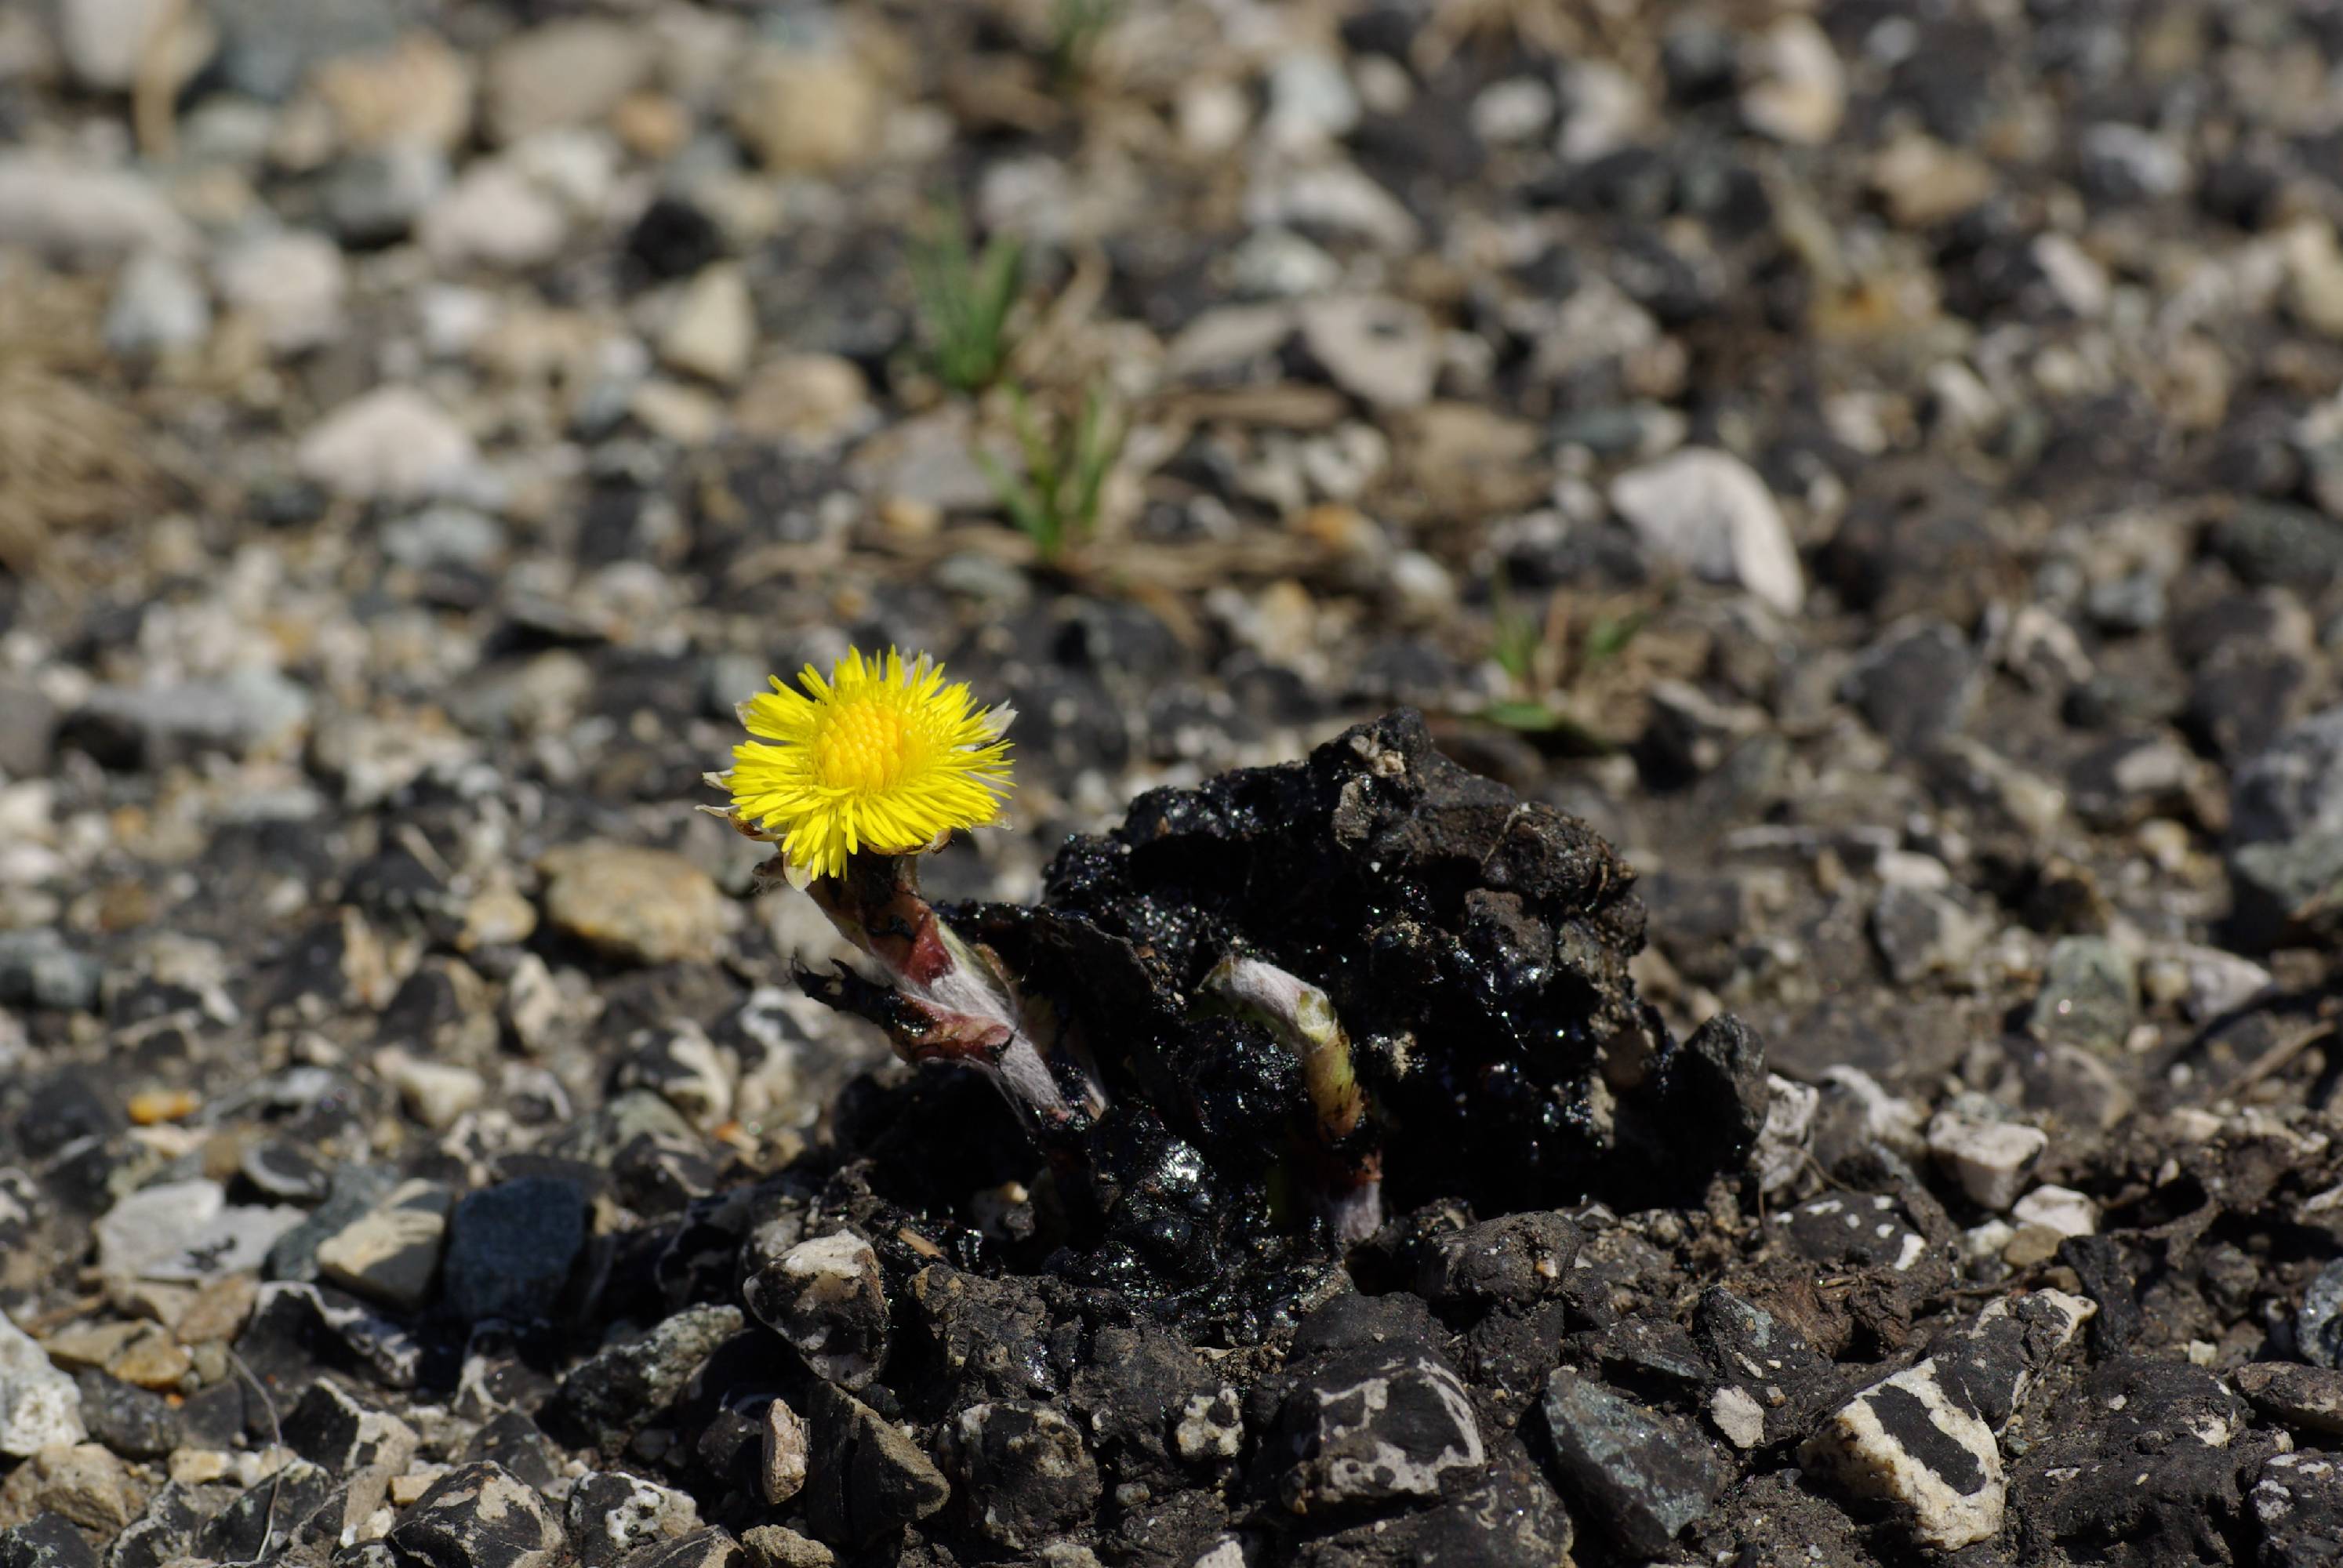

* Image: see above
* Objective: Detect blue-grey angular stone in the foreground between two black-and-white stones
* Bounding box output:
[1544,1367,1734,1556]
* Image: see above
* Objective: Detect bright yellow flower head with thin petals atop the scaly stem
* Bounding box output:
[707,649,1012,886]
